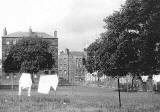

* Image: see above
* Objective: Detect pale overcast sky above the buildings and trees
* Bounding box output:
[0,0,125,55]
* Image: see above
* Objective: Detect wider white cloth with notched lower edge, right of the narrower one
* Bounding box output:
[38,75,58,94]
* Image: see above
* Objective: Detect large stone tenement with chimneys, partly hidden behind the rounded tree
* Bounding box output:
[2,28,58,72]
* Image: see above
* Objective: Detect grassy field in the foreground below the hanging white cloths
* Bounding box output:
[0,86,160,112]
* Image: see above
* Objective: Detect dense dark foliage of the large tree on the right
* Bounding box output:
[87,0,160,76]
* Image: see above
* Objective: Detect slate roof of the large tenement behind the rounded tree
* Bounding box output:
[3,32,55,38]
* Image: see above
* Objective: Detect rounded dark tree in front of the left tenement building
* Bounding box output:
[3,36,54,74]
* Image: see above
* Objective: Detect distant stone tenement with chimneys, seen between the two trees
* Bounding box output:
[58,49,86,83]
